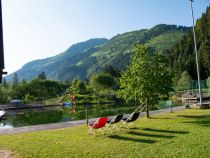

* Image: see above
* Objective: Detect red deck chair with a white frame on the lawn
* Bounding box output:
[87,117,108,136]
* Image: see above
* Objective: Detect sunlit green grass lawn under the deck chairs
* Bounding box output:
[0,110,210,158]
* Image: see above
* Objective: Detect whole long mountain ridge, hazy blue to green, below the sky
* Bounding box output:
[6,24,190,81]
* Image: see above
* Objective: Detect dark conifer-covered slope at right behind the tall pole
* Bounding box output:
[167,6,210,80]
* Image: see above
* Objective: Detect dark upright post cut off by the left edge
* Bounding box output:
[0,0,7,83]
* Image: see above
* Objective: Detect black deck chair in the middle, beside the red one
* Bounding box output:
[104,114,123,132]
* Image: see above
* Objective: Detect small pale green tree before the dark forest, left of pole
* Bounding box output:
[176,71,192,91]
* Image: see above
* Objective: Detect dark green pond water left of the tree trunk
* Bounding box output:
[0,105,144,128]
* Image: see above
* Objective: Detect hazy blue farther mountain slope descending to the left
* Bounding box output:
[6,38,108,80]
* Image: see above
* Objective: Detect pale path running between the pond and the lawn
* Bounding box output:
[0,106,184,135]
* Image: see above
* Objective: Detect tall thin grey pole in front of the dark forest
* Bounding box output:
[189,0,202,105]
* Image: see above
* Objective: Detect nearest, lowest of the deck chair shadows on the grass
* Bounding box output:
[109,135,157,144]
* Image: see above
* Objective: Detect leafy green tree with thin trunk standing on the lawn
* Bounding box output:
[118,45,172,117]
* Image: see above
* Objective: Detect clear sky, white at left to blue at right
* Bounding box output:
[2,0,210,73]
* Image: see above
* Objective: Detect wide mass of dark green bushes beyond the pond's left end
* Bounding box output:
[6,79,66,103]
